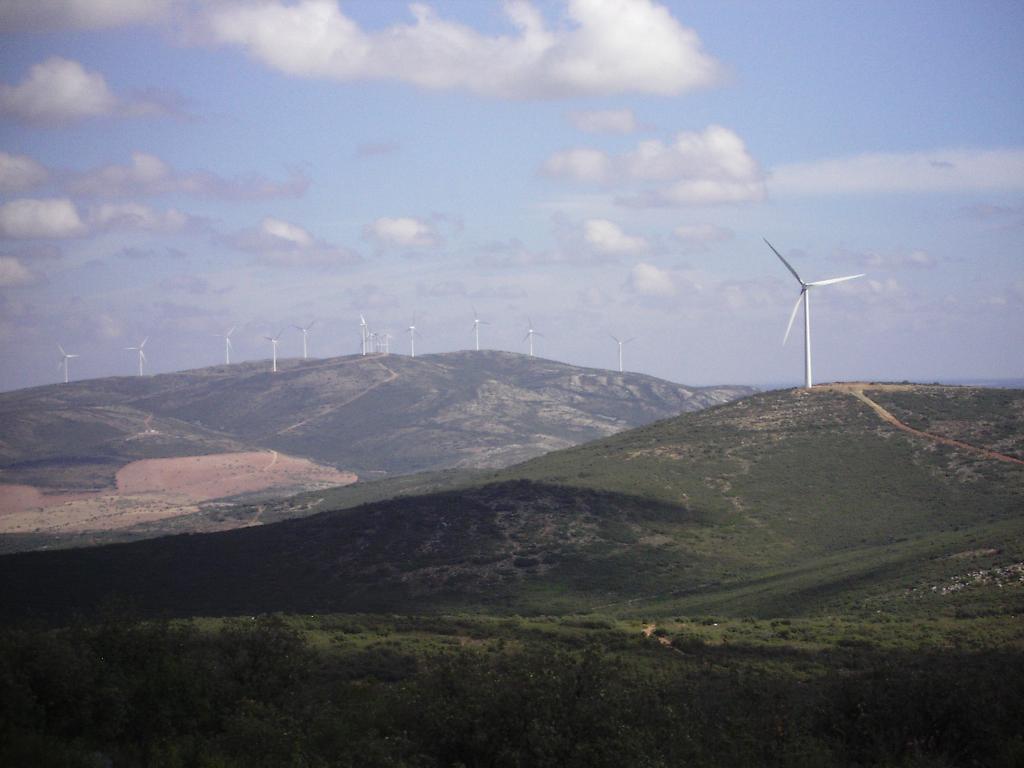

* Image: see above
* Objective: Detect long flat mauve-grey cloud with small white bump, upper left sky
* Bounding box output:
[69,152,309,200]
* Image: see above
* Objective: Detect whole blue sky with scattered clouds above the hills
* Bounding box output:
[0,0,1024,390]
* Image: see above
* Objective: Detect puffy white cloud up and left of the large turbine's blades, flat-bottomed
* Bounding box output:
[543,125,765,206]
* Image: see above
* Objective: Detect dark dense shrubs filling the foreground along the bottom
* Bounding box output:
[0,616,1024,768]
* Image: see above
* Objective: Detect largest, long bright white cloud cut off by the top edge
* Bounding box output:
[206,0,720,98]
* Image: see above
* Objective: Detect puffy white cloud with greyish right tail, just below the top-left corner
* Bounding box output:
[0,56,168,125]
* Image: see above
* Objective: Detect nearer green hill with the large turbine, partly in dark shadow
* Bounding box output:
[0,385,1024,615]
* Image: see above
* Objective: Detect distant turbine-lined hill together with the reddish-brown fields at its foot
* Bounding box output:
[0,352,751,551]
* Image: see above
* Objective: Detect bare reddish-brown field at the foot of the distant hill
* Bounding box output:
[0,451,356,534]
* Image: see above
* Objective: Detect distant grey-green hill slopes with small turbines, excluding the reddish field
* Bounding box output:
[0,351,753,487]
